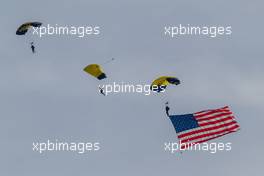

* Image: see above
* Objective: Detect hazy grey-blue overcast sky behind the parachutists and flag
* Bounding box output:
[0,0,264,176]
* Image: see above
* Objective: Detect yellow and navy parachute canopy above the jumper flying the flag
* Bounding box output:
[151,76,180,92]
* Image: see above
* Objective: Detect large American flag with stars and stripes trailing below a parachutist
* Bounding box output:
[170,106,239,149]
